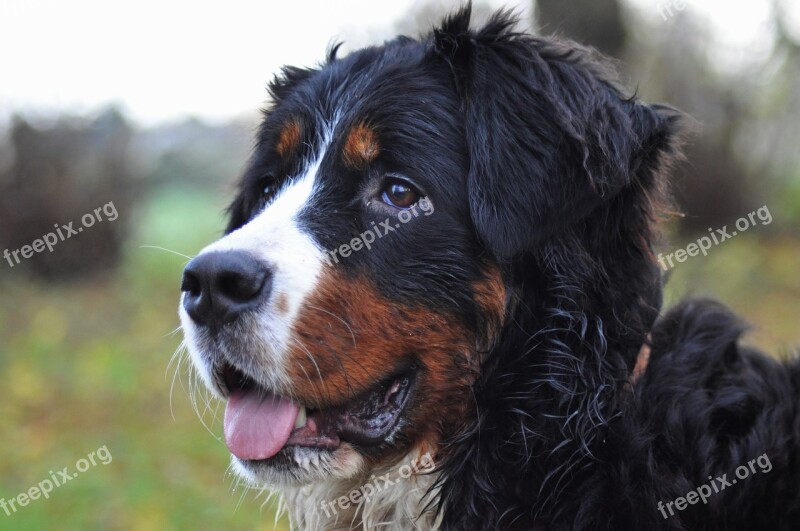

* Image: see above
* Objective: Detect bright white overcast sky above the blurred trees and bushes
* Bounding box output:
[0,0,800,125]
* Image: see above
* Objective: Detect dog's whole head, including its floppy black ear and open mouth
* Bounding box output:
[180,4,673,504]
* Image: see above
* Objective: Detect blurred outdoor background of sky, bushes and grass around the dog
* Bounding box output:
[0,0,800,529]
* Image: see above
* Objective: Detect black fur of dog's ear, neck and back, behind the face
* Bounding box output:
[428,6,800,529]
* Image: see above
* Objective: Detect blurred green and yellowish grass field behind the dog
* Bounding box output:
[0,185,800,530]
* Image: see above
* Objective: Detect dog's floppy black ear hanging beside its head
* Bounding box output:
[434,5,673,260]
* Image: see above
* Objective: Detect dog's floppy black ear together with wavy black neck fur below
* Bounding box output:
[435,3,681,529]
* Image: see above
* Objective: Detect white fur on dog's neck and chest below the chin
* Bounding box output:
[281,453,439,531]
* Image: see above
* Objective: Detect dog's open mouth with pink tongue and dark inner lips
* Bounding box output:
[220,363,415,461]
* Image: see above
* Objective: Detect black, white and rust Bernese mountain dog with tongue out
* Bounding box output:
[179,5,800,530]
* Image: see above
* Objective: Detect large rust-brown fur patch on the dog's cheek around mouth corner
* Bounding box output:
[288,270,477,464]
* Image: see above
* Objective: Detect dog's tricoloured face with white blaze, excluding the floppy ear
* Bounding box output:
[180,32,505,483]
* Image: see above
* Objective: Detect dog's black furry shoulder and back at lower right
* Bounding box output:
[596,299,800,529]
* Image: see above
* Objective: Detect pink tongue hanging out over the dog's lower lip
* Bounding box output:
[225,390,300,459]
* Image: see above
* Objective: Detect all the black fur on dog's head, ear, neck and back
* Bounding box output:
[222,7,800,530]
